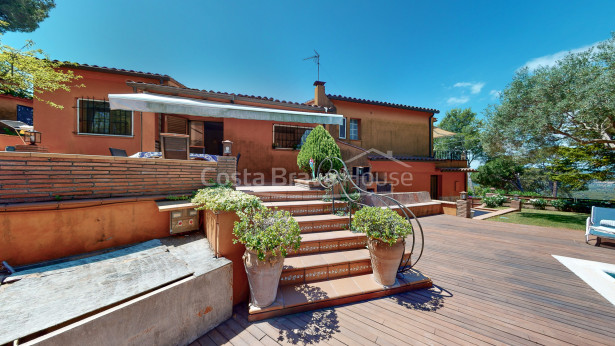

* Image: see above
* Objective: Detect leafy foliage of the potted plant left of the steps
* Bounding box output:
[233,208,301,261]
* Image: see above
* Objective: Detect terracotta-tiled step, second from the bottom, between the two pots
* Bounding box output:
[280,247,410,286]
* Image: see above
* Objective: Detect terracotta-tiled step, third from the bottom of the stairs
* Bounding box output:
[289,230,367,257]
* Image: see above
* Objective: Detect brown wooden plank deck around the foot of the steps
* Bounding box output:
[193,215,615,345]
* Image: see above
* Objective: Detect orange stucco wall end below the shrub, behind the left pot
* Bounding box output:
[205,210,250,305]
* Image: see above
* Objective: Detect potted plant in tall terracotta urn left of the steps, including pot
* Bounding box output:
[233,208,301,308]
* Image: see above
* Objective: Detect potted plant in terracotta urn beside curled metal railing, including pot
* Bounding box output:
[352,207,412,286]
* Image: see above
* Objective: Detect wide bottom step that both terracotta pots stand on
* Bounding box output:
[248,270,433,322]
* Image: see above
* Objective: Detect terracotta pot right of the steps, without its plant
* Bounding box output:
[367,238,406,286]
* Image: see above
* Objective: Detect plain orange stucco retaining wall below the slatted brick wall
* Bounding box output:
[0,201,169,266]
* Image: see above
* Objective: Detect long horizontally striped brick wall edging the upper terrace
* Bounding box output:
[0,152,218,207]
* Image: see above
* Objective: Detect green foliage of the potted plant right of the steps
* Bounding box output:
[352,207,412,245]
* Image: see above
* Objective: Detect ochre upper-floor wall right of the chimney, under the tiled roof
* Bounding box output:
[329,100,431,156]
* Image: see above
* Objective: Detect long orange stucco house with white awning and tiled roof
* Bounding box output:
[0,65,468,199]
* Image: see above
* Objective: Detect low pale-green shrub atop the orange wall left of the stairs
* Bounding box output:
[192,186,263,211]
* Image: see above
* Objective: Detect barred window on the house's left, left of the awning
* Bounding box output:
[77,99,132,136]
